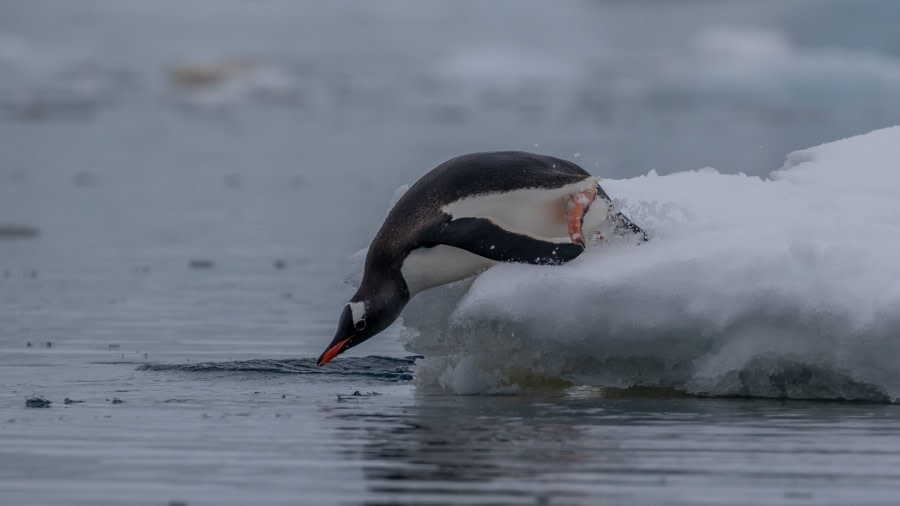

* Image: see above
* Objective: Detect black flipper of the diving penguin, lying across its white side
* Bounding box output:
[434,218,584,265]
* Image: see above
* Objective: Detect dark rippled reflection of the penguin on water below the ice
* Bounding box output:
[340,394,587,504]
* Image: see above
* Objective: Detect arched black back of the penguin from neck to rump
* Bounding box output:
[366,151,590,270]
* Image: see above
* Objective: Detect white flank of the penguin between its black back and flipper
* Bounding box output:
[443,176,607,242]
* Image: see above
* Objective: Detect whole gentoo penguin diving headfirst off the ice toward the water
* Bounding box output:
[317,151,647,366]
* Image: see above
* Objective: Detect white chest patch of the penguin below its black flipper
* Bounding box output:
[400,244,496,297]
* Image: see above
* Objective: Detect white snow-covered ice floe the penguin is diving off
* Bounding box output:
[403,127,900,400]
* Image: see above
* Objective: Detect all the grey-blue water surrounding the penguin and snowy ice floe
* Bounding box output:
[0,0,900,505]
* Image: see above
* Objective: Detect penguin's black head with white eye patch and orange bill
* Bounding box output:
[316,278,409,367]
